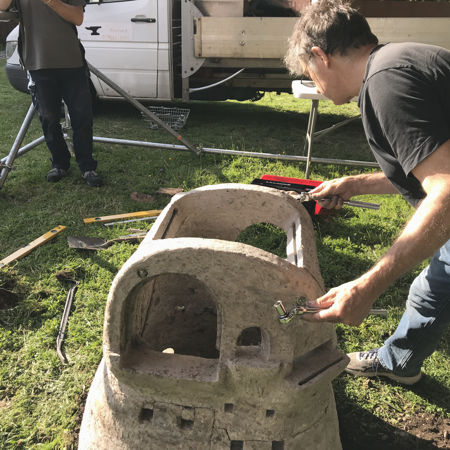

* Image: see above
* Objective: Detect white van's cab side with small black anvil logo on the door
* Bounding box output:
[78,0,170,99]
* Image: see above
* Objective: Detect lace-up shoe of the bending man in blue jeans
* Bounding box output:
[345,349,422,385]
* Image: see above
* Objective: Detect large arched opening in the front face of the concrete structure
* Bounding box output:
[121,273,220,379]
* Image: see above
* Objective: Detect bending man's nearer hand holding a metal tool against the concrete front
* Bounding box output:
[302,278,381,325]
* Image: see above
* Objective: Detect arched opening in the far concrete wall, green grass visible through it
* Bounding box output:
[236,222,287,258]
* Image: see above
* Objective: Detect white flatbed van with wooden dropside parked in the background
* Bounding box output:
[6,0,450,101]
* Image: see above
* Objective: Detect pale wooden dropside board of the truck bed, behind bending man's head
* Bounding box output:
[195,17,450,59]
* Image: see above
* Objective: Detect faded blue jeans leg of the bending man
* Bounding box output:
[378,240,450,376]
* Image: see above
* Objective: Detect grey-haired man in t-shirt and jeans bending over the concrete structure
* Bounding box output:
[285,0,450,384]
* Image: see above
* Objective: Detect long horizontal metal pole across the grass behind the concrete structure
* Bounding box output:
[94,136,380,168]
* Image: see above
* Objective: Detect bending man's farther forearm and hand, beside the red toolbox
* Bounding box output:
[309,172,398,209]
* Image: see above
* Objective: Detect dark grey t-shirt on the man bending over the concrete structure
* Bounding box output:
[359,43,450,206]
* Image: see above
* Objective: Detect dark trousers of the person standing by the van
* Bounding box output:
[29,67,97,172]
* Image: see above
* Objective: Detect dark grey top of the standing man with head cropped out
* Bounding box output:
[12,0,86,70]
